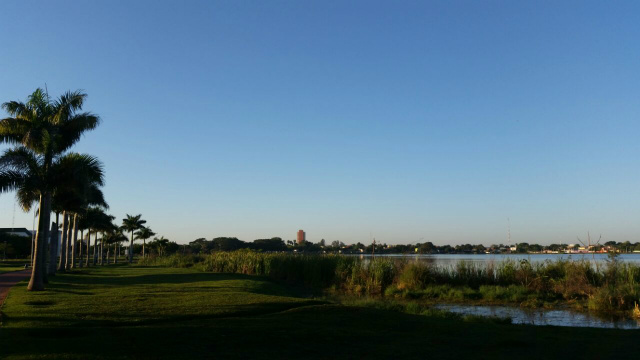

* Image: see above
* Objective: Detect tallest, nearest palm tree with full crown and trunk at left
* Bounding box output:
[0,89,100,291]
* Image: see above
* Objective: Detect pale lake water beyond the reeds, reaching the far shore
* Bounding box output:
[359,253,640,265]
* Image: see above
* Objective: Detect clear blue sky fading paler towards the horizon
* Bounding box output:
[0,1,640,244]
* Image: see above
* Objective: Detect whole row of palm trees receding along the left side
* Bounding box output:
[0,89,160,291]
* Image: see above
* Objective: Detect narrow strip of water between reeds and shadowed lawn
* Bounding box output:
[434,304,640,330]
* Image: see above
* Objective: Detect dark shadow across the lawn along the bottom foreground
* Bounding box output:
[0,306,640,360]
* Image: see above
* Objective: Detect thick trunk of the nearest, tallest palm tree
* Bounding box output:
[27,192,51,291]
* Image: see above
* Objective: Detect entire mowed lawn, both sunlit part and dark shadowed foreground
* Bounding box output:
[0,266,640,360]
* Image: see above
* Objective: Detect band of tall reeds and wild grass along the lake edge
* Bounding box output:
[140,251,640,316]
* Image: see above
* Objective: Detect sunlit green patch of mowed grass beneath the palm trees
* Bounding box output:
[2,266,320,328]
